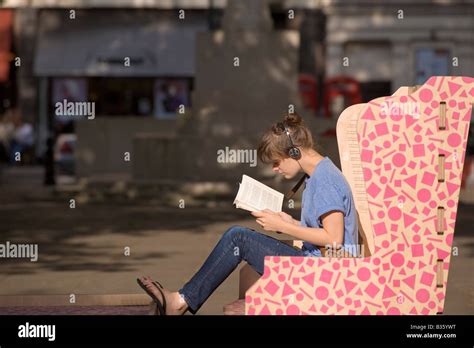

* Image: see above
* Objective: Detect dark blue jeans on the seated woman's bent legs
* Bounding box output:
[178,226,305,314]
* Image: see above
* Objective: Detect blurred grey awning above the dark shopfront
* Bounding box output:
[34,10,207,76]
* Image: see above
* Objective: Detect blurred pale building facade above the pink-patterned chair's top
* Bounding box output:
[325,1,474,100]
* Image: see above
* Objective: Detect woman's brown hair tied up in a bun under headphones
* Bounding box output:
[258,113,315,163]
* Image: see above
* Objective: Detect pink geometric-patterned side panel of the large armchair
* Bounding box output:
[245,76,474,315]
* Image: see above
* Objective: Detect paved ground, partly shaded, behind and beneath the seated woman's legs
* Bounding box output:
[0,168,474,314]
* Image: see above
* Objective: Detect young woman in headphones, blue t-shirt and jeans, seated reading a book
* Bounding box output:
[137,114,358,315]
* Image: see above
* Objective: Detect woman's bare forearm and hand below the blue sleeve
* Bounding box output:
[252,209,344,246]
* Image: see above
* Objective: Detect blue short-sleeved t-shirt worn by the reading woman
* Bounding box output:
[301,156,359,256]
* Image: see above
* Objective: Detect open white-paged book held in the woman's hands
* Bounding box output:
[234,174,284,212]
